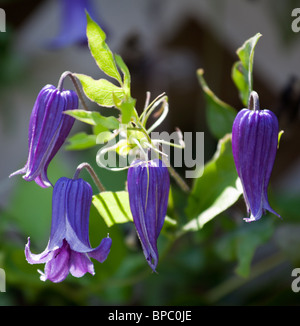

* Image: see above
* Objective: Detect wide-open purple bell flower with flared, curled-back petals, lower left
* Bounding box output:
[25,177,112,283]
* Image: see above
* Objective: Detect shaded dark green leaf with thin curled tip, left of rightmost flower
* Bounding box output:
[197,69,237,139]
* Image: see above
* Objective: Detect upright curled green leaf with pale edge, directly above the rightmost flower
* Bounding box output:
[232,33,262,106]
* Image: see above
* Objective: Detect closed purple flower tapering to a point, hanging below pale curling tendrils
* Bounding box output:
[127,159,170,272]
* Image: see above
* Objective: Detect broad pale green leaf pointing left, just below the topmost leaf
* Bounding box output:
[75,74,125,107]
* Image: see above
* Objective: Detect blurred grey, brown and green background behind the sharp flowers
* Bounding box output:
[0,0,300,305]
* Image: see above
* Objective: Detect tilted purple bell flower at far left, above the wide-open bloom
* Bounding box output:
[10,85,78,188]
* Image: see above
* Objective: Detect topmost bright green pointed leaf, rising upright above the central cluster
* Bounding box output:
[86,14,122,85]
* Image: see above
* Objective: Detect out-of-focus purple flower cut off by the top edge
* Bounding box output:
[48,0,103,49]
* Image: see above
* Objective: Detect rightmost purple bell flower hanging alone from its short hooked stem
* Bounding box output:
[232,92,280,222]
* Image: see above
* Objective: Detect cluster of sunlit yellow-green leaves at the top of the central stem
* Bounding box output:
[66,14,136,150]
